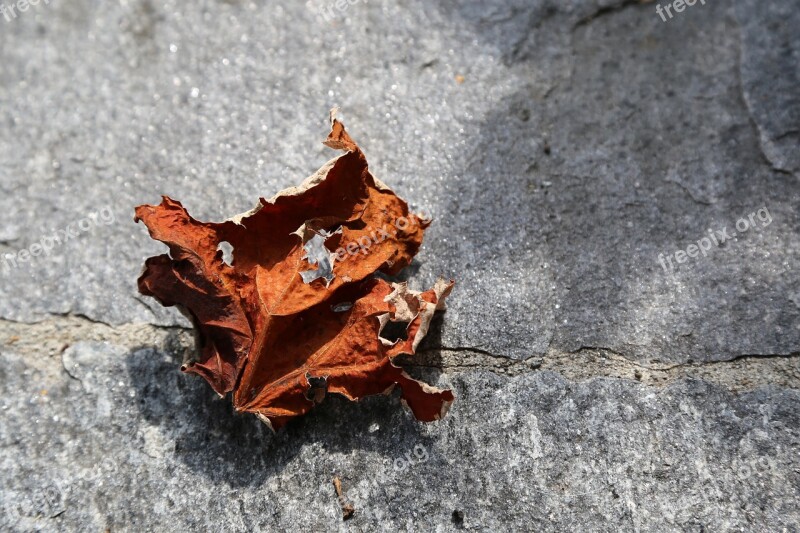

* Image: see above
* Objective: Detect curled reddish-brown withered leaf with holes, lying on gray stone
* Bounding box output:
[136,110,453,429]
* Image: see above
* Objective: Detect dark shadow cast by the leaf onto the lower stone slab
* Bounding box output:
[126,328,432,486]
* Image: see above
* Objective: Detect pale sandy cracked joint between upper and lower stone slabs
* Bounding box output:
[0,313,800,392]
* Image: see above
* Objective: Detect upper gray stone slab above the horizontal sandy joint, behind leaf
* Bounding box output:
[0,1,800,361]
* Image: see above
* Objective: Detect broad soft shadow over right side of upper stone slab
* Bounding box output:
[418,1,800,363]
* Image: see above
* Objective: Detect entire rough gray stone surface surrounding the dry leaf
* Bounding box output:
[0,0,800,531]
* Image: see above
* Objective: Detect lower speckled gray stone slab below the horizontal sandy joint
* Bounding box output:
[0,330,800,531]
